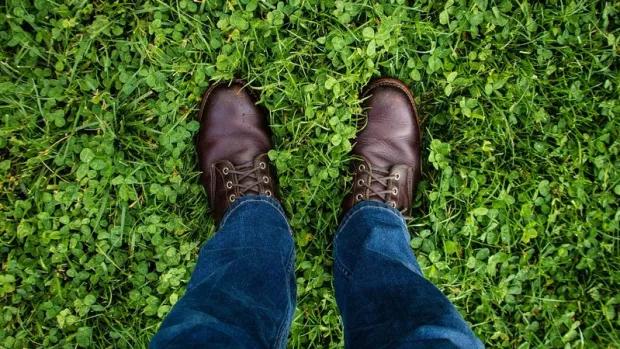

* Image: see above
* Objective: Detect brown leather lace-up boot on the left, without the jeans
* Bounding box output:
[196,80,279,226]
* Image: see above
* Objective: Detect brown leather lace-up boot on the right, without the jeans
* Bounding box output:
[342,78,420,215]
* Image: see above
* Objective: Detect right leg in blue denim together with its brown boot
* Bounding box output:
[334,78,482,349]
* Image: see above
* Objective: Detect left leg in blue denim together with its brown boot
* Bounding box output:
[151,80,297,348]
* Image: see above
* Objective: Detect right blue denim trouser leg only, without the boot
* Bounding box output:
[334,202,483,349]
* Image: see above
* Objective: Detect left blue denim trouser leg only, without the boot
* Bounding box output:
[151,196,297,348]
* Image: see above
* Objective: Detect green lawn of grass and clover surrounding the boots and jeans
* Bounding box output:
[0,0,620,348]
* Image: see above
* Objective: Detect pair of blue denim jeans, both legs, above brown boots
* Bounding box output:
[151,196,483,349]
